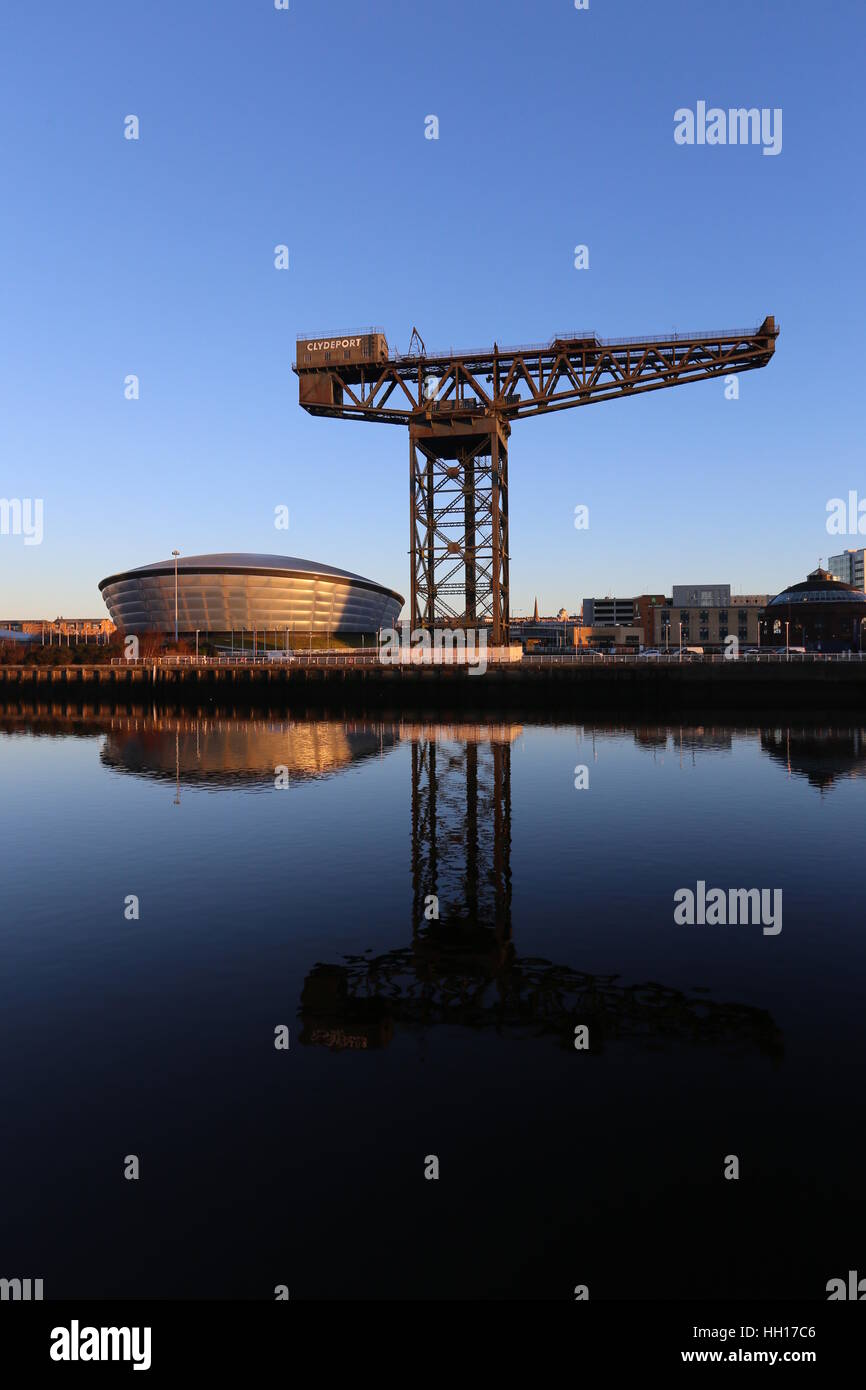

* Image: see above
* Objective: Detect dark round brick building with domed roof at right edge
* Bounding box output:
[762,566,866,652]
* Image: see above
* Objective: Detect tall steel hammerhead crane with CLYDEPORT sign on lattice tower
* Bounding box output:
[293,317,778,646]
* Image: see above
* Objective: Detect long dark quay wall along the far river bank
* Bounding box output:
[0,660,866,714]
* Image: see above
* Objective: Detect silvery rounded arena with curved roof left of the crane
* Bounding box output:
[99,555,403,646]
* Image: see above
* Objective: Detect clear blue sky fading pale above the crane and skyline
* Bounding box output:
[0,0,866,619]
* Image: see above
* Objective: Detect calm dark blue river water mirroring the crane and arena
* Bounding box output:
[0,710,866,1298]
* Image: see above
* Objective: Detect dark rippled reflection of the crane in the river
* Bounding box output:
[300,724,781,1056]
